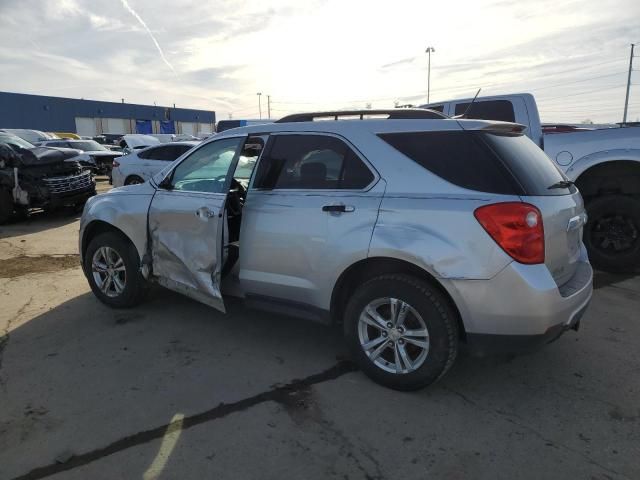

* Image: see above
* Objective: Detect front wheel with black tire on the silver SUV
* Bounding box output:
[84,232,147,308]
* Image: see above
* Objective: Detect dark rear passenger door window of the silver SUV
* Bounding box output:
[254,135,374,190]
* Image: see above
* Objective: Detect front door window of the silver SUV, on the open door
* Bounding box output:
[171,137,244,193]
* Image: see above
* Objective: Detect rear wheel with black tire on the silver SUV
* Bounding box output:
[344,274,458,391]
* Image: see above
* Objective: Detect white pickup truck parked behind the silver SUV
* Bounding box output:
[421,93,640,272]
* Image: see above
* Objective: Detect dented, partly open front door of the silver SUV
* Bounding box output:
[148,136,245,311]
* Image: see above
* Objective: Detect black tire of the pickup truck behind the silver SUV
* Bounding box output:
[583,195,640,272]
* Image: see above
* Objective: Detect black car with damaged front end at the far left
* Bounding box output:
[0,142,96,224]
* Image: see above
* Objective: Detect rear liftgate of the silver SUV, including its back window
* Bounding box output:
[480,133,586,286]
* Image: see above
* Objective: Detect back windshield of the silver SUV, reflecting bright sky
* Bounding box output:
[478,133,575,195]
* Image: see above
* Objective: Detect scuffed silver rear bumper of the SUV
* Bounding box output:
[448,246,593,354]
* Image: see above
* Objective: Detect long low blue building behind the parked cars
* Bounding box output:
[0,92,216,136]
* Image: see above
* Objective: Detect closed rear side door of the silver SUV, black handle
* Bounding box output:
[240,132,384,316]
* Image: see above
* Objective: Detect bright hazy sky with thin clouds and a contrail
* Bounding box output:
[0,0,640,123]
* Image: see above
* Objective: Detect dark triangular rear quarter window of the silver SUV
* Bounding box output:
[379,131,521,195]
